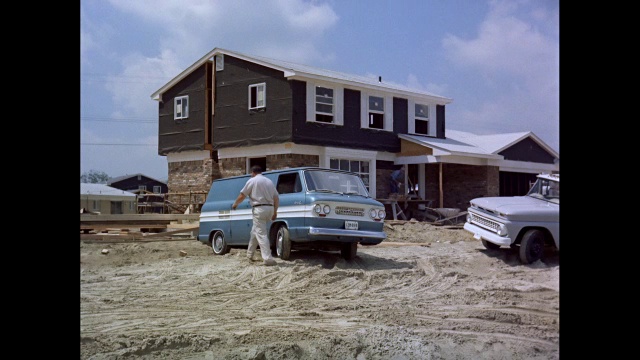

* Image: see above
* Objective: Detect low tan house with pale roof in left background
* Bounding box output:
[80,183,137,214]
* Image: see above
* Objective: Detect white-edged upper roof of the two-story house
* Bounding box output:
[151,48,452,105]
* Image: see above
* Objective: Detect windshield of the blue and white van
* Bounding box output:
[304,170,369,197]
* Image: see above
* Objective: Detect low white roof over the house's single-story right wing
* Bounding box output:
[398,129,559,159]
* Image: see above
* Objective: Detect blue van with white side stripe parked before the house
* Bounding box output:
[198,167,387,260]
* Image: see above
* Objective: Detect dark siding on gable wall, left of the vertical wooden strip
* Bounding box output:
[158,64,207,155]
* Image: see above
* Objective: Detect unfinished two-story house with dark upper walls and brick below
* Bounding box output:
[151,48,559,208]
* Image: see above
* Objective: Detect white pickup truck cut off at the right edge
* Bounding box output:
[464,174,560,264]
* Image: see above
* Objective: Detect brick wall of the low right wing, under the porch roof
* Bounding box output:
[425,164,500,211]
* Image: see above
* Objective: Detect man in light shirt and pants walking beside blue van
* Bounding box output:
[231,165,280,266]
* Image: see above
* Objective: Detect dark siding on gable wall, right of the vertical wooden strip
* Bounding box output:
[213,55,292,149]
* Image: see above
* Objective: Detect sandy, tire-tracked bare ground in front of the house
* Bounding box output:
[80,222,560,360]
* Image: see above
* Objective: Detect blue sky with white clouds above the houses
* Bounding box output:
[80,0,560,181]
